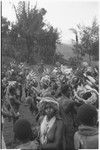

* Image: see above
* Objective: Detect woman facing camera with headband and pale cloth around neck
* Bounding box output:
[39,97,65,150]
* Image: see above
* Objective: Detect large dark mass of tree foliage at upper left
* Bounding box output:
[2,1,59,64]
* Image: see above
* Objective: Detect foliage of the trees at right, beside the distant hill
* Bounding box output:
[70,18,99,61]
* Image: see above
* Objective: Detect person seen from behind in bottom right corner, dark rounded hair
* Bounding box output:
[74,104,99,150]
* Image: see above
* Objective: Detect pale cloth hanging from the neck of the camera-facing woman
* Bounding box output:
[40,116,56,144]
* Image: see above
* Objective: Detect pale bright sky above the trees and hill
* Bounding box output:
[2,0,100,44]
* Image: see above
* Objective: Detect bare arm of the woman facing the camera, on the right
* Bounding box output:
[42,120,63,150]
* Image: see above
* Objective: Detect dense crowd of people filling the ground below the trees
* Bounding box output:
[1,62,99,150]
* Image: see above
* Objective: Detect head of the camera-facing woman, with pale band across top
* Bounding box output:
[38,97,59,118]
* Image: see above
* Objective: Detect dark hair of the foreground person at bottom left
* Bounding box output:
[14,119,33,142]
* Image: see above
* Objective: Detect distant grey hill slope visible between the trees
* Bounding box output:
[56,44,75,59]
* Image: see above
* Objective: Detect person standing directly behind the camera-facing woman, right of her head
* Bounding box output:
[57,85,76,150]
